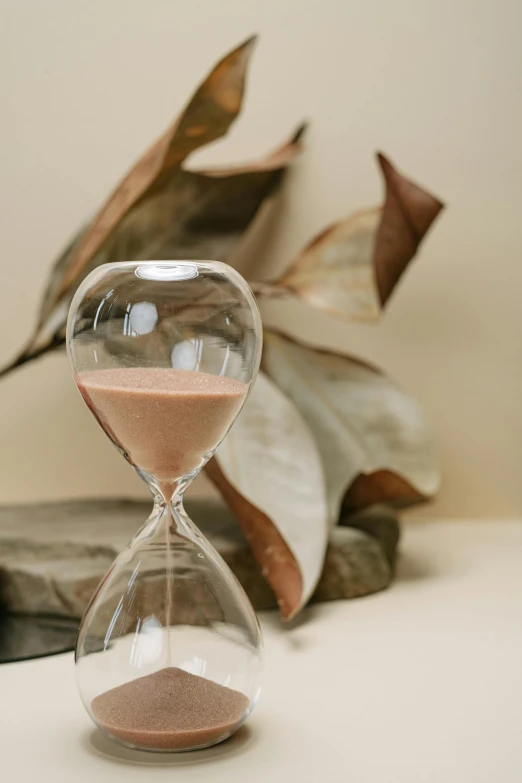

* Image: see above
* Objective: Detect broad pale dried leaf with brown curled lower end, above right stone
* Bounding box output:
[262,332,438,523]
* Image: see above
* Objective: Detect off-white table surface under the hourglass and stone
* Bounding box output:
[0,521,522,783]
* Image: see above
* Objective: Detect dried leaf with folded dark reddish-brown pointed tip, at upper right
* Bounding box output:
[254,154,443,321]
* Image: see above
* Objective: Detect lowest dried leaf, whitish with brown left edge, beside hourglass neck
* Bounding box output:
[206,373,328,619]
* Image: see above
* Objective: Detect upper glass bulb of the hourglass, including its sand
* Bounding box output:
[68,261,261,500]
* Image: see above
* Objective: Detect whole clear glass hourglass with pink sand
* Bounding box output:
[67,261,262,751]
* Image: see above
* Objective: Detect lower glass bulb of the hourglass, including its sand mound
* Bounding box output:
[76,502,262,751]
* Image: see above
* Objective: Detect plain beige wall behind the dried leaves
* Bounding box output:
[0,0,522,517]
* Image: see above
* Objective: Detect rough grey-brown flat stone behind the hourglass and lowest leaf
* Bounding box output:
[0,500,398,618]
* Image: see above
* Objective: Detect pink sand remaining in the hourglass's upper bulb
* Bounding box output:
[76,367,248,484]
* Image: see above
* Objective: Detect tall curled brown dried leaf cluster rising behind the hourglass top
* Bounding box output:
[0,40,304,376]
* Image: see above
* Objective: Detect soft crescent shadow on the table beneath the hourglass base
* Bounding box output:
[82,725,255,767]
